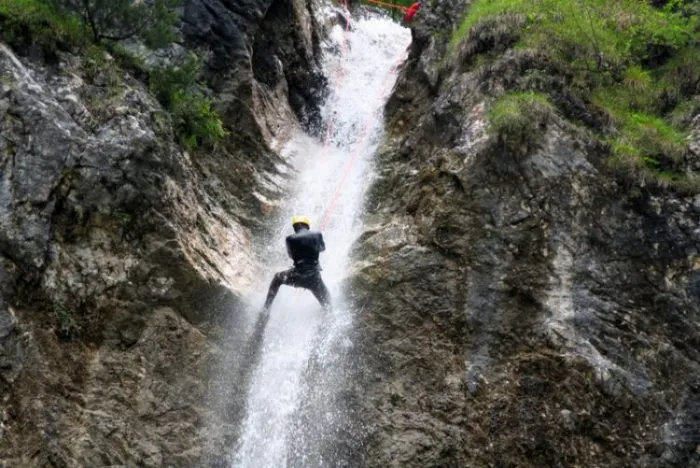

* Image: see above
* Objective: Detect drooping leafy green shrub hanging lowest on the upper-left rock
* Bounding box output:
[150,54,226,150]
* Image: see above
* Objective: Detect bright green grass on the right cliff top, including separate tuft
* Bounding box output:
[450,0,700,192]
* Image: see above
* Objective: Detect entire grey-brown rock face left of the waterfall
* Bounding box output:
[0,0,323,466]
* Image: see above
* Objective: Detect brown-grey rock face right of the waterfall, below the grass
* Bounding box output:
[345,1,700,467]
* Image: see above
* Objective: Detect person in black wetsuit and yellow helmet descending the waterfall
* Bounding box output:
[263,216,331,313]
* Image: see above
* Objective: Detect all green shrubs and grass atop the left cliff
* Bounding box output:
[0,0,226,149]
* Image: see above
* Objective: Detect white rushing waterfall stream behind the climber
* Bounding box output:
[233,11,410,467]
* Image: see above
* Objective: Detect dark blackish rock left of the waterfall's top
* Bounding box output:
[183,0,325,132]
